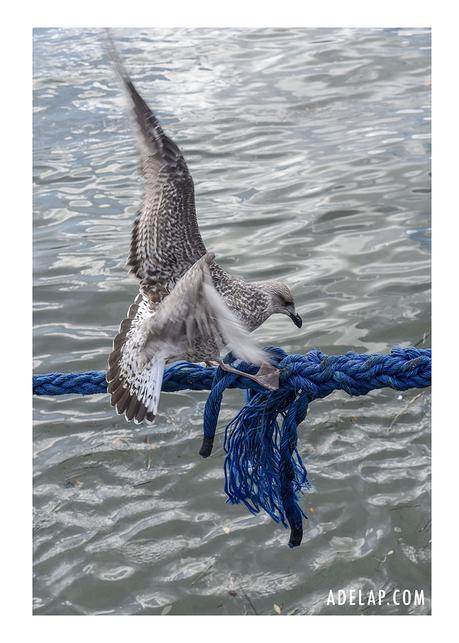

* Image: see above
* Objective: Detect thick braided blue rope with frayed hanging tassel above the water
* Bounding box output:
[33,347,432,547]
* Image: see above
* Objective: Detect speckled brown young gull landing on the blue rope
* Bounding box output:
[107,34,302,424]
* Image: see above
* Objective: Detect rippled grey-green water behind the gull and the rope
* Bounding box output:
[34,29,430,614]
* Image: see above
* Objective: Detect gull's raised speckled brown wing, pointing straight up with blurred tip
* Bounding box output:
[108,34,206,288]
